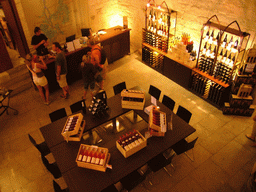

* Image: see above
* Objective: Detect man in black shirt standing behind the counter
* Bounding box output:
[31,27,49,56]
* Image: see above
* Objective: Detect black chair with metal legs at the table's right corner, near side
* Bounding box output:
[172,137,198,161]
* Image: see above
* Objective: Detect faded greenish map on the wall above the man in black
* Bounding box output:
[39,0,70,41]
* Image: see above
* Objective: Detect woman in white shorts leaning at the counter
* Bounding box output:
[26,54,50,105]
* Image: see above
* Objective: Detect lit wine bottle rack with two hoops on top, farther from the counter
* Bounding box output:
[191,15,250,106]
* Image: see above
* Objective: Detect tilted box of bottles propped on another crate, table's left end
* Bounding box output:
[61,113,85,142]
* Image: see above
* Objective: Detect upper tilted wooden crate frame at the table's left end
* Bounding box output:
[61,113,83,138]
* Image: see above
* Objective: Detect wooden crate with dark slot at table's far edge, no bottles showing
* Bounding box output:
[121,89,145,110]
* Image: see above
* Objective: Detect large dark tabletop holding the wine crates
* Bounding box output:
[40,89,195,191]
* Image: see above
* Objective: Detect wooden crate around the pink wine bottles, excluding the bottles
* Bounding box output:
[76,144,110,172]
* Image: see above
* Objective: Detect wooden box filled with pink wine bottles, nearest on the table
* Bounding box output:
[76,144,110,172]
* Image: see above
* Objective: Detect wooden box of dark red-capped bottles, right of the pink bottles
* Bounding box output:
[116,130,147,158]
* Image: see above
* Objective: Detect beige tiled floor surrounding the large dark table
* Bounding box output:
[0,51,256,192]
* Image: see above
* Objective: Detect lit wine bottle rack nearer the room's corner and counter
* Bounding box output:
[142,1,177,71]
